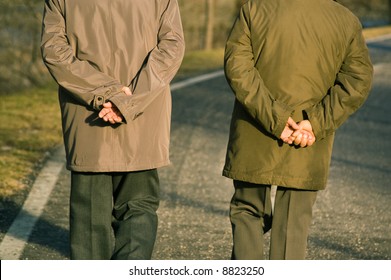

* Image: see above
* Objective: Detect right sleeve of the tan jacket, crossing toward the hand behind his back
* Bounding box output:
[110,0,185,121]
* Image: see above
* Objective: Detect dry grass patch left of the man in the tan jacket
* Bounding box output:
[0,85,61,197]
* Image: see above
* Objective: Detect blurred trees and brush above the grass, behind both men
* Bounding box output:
[0,0,391,94]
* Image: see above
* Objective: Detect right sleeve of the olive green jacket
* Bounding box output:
[305,27,373,140]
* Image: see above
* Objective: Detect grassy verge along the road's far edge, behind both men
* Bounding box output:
[0,26,391,199]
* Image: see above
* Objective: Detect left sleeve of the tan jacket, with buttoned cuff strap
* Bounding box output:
[41,0,123,110]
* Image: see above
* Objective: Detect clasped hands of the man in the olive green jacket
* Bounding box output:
[280,117,315,148]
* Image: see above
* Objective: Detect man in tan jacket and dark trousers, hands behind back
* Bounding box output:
[42,0,184,259]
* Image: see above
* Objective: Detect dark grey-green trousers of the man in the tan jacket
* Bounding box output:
[70,169,159,260]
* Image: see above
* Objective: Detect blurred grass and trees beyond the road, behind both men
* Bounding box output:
[0,0,391,199]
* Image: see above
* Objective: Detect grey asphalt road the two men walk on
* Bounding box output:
[0,36,391,260]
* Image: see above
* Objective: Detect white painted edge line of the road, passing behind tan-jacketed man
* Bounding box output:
[0,70,224,260]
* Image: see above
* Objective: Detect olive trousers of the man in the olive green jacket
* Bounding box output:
[230,181,317,260]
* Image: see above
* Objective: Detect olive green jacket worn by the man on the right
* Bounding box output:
[223,0,373,190]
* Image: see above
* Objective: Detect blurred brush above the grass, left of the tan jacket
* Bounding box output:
[0,0,49,94]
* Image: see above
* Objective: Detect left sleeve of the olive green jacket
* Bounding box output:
[224,5,293,138]
